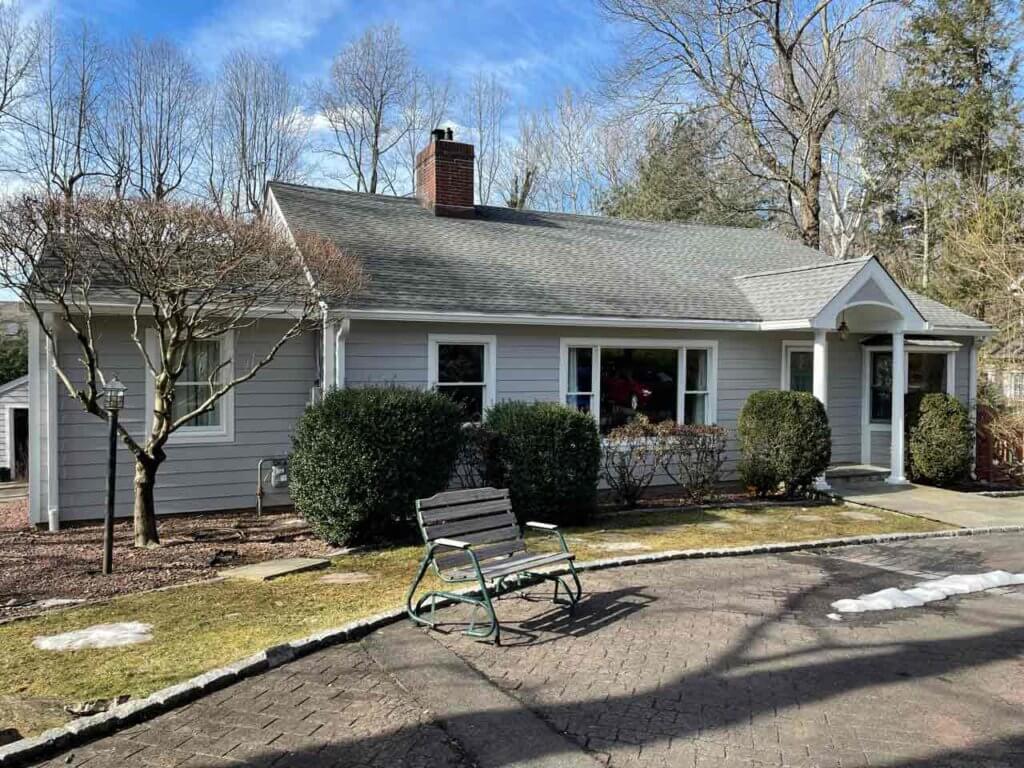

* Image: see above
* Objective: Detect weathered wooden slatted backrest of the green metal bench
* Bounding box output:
[416,488,526,570]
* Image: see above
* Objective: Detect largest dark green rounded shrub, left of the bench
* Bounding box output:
[290,388,463,544]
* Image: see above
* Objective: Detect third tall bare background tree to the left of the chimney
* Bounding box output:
[113,40,207,201]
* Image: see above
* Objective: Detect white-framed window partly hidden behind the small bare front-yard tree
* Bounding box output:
[145,331,234,444]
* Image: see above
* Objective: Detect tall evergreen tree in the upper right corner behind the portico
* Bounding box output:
[867,0,1021,289]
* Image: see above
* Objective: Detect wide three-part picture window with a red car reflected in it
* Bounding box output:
[562,339,715,433]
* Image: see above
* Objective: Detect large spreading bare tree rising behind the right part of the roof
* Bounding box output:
[601,0,898,248]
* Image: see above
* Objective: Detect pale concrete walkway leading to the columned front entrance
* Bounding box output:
[831,480,1024,527]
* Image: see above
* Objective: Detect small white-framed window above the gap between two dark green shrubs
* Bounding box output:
[429,336,495,422]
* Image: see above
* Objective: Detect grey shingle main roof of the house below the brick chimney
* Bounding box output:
[270,182,991,333]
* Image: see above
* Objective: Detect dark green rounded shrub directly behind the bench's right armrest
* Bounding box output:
[485,402,601,524]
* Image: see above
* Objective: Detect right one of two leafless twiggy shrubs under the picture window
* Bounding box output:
[658,422,728,504]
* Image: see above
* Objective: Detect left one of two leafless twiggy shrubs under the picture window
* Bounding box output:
[601,415,669,507]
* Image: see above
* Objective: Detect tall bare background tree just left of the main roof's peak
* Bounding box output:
[203,51,309,215]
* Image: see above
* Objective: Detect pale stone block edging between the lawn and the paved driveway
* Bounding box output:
[0,525,1024,768]
